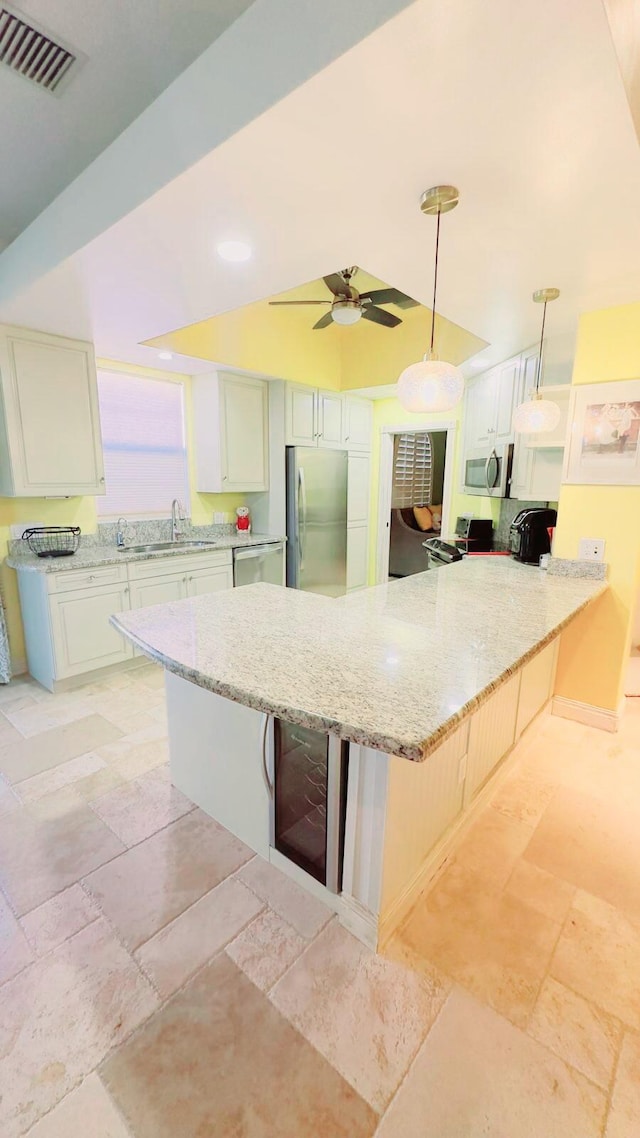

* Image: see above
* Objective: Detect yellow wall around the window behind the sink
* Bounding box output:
[0,360,243,670]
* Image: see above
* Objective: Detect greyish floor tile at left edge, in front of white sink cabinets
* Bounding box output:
[0,715,122,783]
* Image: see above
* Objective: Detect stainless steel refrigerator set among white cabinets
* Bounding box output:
[287,446,347,596]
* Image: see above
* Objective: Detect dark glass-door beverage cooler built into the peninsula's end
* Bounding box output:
[271,719,348,893]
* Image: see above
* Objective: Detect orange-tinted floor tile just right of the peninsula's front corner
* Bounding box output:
[399,863,560,1025]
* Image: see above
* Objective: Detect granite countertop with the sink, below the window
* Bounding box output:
[6,534,286,572]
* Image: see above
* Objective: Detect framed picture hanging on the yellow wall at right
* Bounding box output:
[563,379,640,486]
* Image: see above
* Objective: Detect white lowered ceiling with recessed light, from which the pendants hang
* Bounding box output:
[0,0,640,380]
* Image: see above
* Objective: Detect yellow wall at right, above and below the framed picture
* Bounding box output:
[553,303,640,711]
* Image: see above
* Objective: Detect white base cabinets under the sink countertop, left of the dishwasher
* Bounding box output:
[18,551,233,692]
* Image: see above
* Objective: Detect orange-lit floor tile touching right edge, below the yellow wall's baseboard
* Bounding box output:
[525,790,640,921]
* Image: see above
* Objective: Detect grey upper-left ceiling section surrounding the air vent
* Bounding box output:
[0,0,253,248]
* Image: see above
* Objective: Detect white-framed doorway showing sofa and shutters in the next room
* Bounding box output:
[376,423,456,583]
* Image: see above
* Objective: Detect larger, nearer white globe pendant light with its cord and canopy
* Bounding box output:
[397,185,465,412]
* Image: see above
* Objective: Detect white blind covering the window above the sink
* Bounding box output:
[97,371,189,518]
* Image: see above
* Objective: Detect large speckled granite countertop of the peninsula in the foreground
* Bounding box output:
[112,558,607,761]
